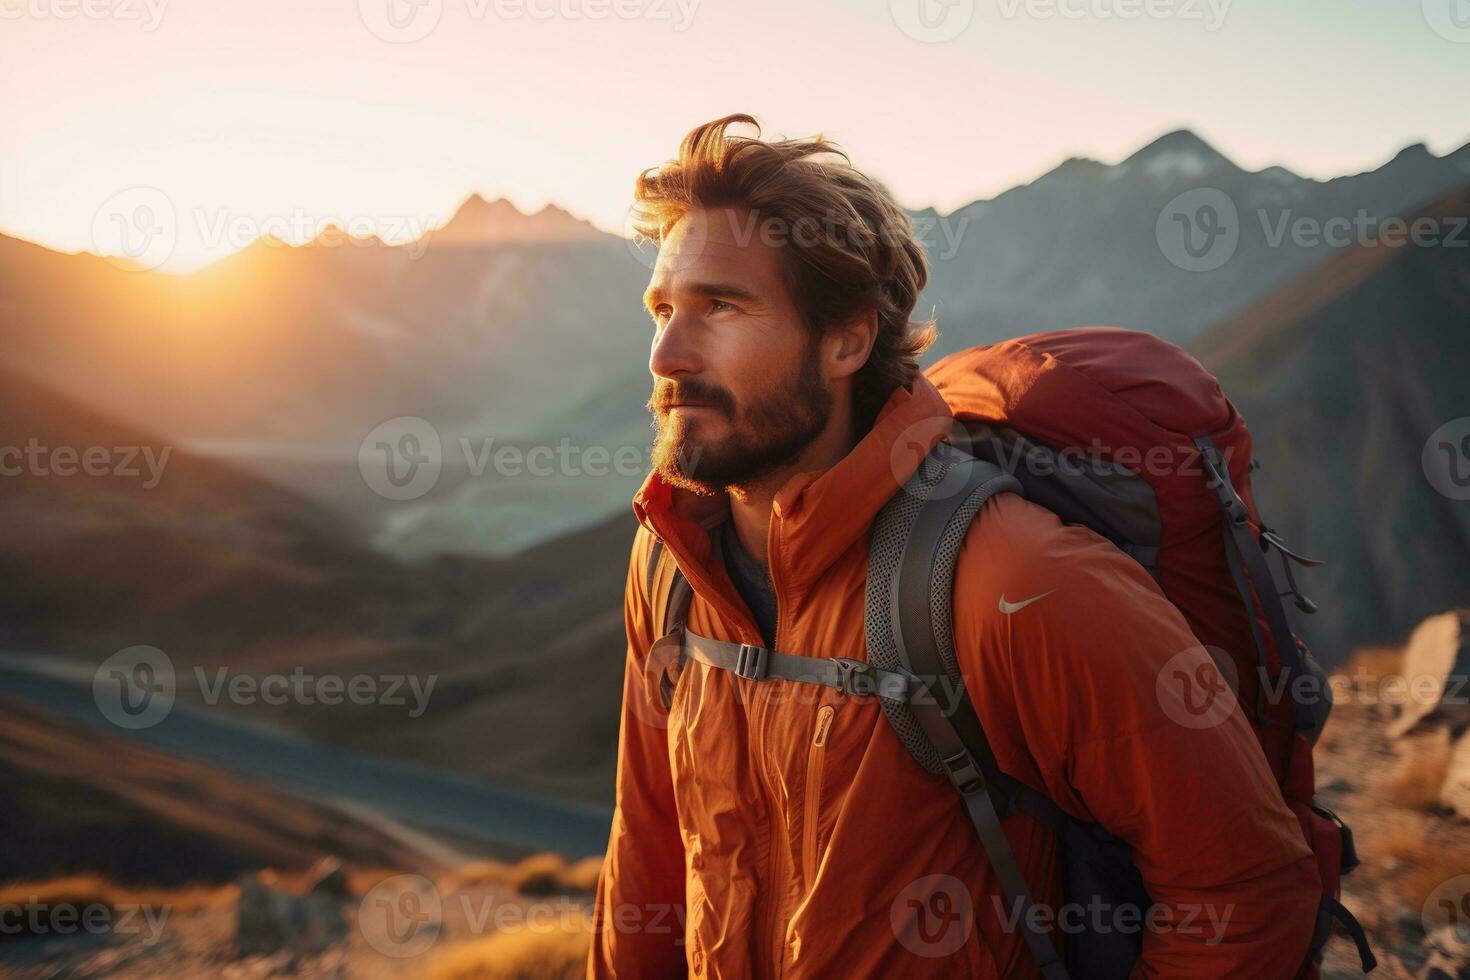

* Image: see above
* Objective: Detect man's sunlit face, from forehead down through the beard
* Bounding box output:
[644,210,832,494]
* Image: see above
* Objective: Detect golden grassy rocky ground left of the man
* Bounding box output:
[0,855,595,980]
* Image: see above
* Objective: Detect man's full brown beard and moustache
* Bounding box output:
[648,341,832,494]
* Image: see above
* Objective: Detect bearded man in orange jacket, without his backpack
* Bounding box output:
[589,116,1320,979]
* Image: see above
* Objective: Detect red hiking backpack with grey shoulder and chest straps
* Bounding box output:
[647,328,1376,980]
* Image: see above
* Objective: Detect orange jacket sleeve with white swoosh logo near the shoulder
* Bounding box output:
[956,495,1322,980]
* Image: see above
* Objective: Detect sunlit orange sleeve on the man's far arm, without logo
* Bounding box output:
[587,529,686,980]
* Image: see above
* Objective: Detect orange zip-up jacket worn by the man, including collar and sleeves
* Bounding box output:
[588,378,1320,980]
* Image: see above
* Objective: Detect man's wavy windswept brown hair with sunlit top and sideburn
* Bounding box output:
[634,113,935,432]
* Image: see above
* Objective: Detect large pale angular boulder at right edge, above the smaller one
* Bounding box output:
[1379,610,1470,738]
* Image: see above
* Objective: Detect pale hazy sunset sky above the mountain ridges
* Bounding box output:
[0,0,1470,267]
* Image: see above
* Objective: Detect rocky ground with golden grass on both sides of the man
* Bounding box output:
[0,649,1470,980]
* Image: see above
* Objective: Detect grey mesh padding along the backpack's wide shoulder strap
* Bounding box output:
[863,442,992,774]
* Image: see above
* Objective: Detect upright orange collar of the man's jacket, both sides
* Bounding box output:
[632,375,953,619]
